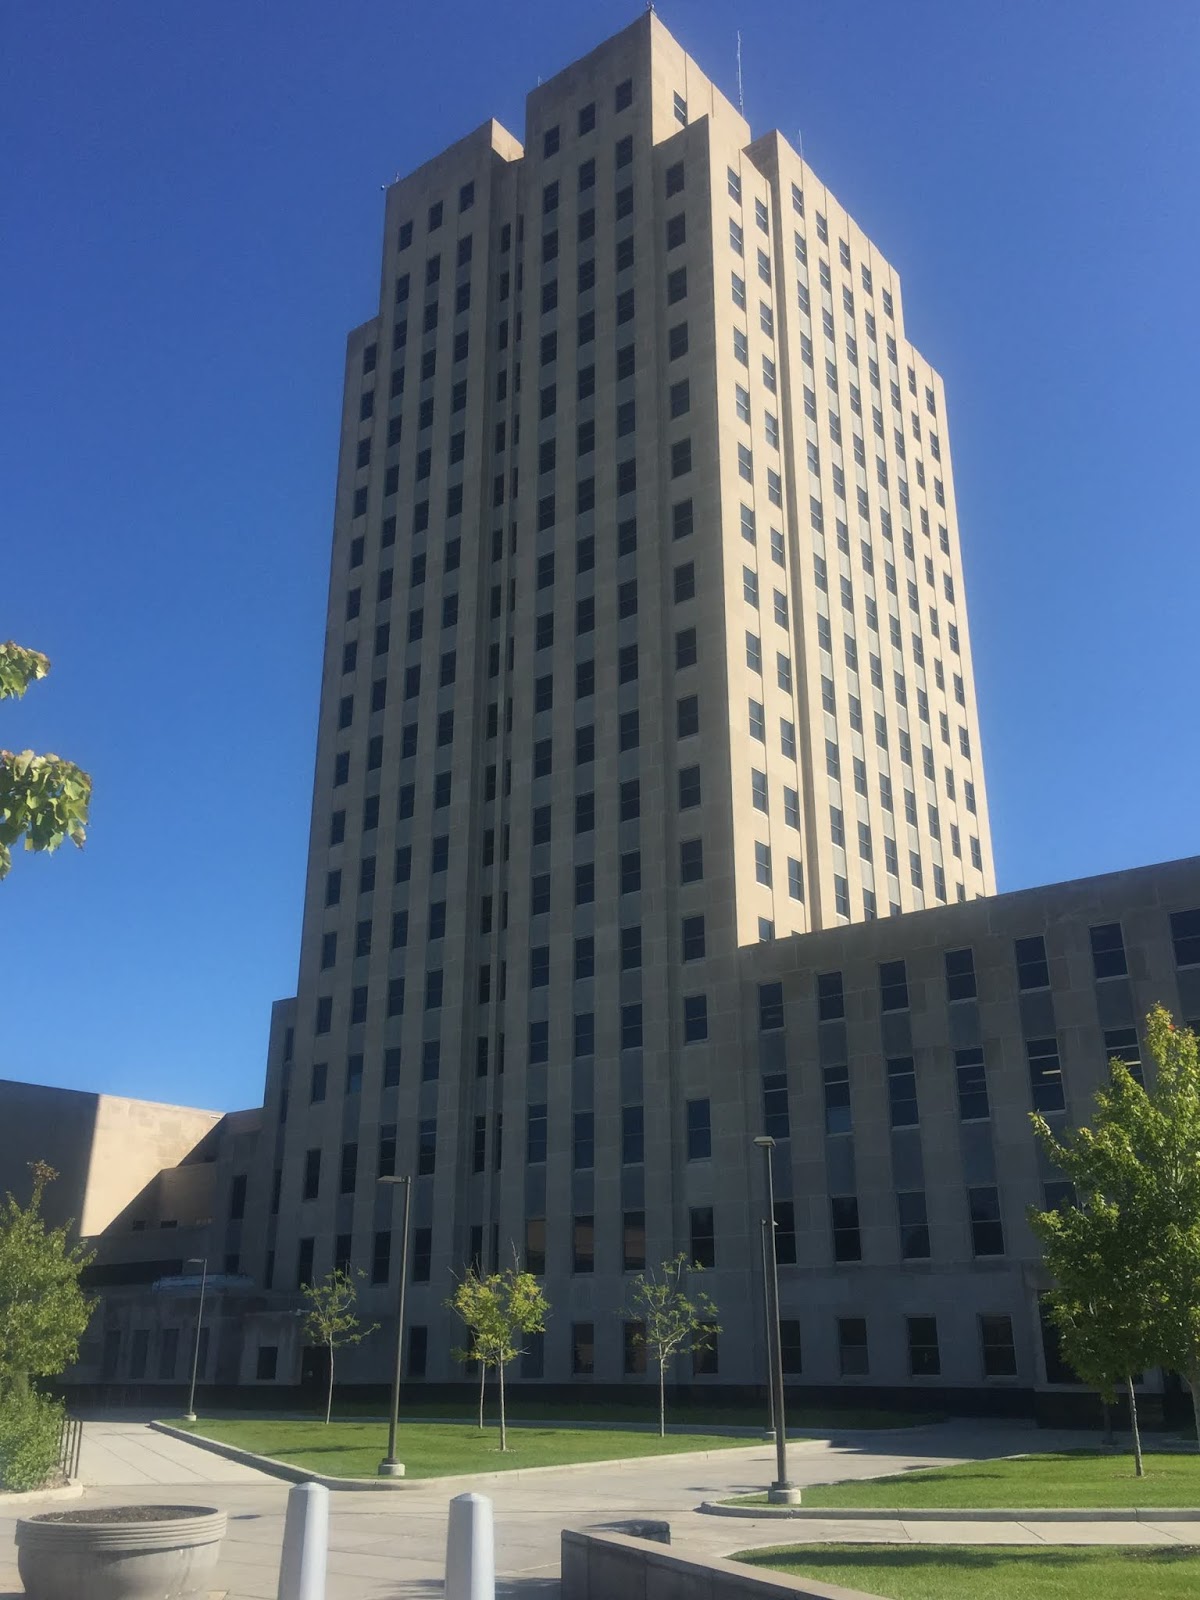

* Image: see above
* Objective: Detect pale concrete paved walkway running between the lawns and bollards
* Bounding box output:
[0,1421,1200,1600]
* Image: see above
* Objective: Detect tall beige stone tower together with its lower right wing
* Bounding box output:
[51,14,1200,1408]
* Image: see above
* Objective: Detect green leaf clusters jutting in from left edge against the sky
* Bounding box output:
[0,640,91,878]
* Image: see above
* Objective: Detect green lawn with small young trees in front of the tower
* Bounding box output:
[171,1418,761,1478]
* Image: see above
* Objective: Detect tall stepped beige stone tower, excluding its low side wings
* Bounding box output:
[251,14,995,1379]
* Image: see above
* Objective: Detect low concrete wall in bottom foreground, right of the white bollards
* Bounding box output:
[562,1528,878,1600]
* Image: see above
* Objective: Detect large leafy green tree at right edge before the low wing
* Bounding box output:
[1034,1005,1200,1442]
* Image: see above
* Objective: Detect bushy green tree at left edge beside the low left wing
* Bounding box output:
[0,1162,93,1402]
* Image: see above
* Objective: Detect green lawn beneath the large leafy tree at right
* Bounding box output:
[723,1450,1200,1510]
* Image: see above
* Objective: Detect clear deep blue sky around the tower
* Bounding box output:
[0,0,1200,1106]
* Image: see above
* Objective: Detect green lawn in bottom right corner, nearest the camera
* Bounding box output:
[734,1544,1200,1600]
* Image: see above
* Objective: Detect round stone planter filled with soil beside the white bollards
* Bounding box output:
[16,1506,226,1600]
